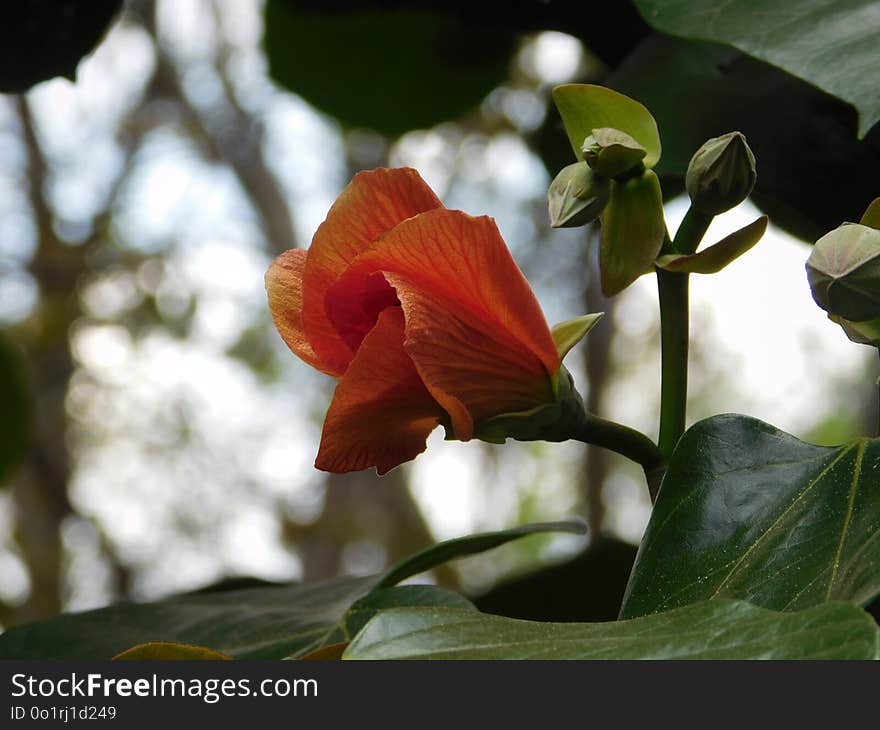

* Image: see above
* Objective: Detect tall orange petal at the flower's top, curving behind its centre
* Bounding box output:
[302,168,442,376]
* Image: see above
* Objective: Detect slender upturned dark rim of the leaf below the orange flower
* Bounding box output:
[376,520,586,590]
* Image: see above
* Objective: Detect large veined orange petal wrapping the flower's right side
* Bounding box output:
[328,209,559,440]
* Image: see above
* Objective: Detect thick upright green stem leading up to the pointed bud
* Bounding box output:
[657,207,712,460]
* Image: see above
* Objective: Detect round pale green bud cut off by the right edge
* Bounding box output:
[807,223,880,322]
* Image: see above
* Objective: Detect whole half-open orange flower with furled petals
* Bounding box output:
[266,168,560,474]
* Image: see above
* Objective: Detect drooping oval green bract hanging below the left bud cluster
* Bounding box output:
[599,170,666,297]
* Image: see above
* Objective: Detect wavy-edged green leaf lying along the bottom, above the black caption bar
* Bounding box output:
[343,600,878,659]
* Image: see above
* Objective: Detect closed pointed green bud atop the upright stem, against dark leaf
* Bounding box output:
[685,132,757,215]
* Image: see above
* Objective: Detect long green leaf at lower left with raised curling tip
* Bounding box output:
[0,521,584,659]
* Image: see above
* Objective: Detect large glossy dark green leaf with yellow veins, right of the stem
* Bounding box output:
[621,414,880,618]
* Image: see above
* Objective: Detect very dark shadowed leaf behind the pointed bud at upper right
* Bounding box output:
[607,35,880,242]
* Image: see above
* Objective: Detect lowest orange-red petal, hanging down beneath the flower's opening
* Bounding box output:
[315,307,443,474]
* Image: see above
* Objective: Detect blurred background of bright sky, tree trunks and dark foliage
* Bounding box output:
[0,0,880,627]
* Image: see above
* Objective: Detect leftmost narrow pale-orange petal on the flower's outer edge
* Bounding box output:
[266,249,333,375]
